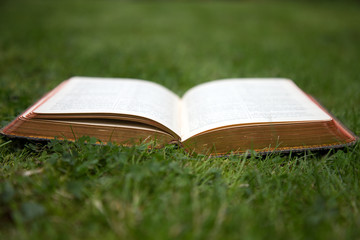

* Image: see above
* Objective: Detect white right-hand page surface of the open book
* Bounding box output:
[181,79,331,141]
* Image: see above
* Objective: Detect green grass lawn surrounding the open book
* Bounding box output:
[0,1,360,239]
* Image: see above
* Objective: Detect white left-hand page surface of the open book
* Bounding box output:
[34,77,180,135]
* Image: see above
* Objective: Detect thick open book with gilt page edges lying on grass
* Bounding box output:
[2,77,357,154]
